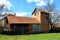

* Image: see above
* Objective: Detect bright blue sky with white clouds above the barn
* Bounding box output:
[0,0,60,17]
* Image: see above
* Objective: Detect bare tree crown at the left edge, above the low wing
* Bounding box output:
[0,4,16,17]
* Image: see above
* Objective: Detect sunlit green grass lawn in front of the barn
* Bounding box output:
[0,33,60,40]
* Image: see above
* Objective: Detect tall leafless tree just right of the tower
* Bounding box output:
[44,3,58,29]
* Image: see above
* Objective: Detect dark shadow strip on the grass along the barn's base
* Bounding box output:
[1,30,60,35]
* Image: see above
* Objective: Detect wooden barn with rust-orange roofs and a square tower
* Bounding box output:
[0,8,50,34]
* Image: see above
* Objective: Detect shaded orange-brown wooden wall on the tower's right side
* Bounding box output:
[41,13,49,32]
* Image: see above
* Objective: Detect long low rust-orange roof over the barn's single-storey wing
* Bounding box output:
[7,16,39,24]
